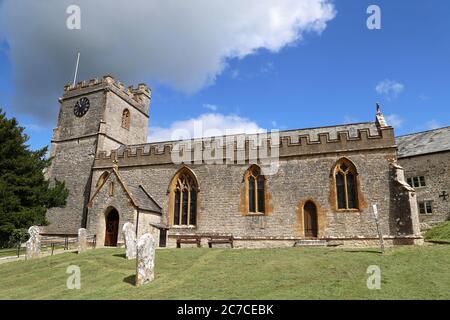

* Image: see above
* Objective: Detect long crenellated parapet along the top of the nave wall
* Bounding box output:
[94,123,395,167]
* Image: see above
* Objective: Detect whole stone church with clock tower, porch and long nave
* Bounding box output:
[44,76,449,247]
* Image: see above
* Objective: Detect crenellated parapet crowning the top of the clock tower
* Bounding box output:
[60,75,151,114]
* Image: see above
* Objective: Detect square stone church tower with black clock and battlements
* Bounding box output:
[45,76,151,234]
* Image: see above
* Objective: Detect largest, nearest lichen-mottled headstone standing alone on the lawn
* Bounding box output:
[136,233,156,286]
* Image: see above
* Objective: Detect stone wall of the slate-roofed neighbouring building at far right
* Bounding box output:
[398,151,450,228]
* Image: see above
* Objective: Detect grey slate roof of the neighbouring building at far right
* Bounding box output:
[395,126,450,158]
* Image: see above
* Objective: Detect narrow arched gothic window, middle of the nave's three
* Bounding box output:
[245,165,266,213]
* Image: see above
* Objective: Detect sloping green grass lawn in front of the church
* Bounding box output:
[0,245,450,299]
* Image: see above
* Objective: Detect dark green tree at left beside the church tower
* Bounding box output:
[0,108,69,247]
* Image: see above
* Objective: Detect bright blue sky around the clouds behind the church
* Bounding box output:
[0,0,450,148]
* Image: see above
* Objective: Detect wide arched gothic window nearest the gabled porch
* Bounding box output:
[170,169,198,226]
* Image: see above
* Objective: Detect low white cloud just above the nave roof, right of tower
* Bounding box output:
[148,113,266,142]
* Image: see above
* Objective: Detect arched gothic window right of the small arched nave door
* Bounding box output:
[334,159,358,210]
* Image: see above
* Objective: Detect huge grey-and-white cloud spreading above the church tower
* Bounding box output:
[0,0,336,120]
